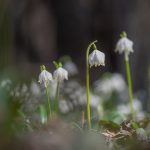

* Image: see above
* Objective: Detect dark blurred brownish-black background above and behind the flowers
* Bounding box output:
[0,0,150,96]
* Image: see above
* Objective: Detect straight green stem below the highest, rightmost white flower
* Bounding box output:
[125,55,135,121]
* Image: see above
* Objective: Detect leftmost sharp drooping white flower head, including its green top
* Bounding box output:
[39,65,53,87]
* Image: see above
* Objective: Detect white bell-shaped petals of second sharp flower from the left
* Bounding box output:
[53,67,68,82]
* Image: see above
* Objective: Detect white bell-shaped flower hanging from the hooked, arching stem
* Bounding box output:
[89,49,105,67]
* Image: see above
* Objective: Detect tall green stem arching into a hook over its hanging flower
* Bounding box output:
[86,41,97,128]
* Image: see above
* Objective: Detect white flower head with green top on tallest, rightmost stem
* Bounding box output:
[115,32,133,58]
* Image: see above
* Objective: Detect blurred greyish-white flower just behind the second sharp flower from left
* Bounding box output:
[63,60,78,76]
